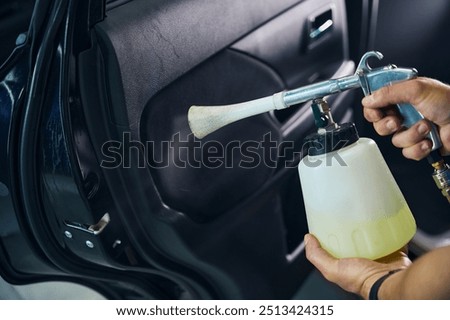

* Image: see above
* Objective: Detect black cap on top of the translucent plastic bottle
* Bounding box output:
[304,122,359,156]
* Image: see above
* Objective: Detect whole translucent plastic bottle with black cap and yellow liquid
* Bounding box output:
[299,123,416,259]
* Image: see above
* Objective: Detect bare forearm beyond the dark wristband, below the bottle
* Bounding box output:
[378,246,450,300]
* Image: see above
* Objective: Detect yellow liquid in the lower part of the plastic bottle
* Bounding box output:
[307,205,416,260]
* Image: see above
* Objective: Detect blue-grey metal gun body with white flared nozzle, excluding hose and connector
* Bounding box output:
[188,51,442,150]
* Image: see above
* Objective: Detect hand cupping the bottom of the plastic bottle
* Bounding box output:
[304,234,411,299]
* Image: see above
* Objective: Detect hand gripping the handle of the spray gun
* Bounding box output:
[362,78,450,160]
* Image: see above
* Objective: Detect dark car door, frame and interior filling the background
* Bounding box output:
[0,0,450,299]
